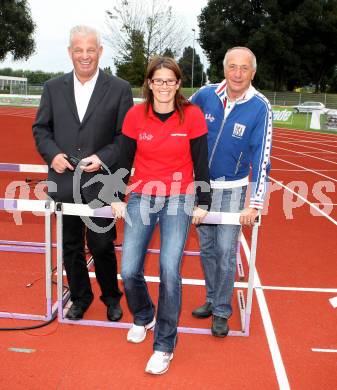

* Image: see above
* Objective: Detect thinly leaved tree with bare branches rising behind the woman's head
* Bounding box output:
[106,0,186,84]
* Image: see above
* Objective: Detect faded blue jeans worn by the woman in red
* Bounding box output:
[121,193,194,352]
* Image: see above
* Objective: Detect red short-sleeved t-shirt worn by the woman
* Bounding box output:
[122,104,207,196]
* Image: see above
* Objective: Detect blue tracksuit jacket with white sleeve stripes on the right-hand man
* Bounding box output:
[190,80,272,209]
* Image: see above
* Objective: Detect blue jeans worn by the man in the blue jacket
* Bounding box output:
[197,186,247,318]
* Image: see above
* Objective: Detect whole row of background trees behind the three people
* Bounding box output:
[0,0,337,92]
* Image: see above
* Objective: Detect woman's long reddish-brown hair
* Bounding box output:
[143,56,190,122]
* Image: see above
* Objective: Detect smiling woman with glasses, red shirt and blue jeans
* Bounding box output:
[111,57,210,374]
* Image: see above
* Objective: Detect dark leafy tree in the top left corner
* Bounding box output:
[0,0,35,61]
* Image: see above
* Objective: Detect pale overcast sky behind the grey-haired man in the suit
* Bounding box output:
[0,0,207,72]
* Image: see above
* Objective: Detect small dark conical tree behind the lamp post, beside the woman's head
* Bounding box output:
[178,46,206,87]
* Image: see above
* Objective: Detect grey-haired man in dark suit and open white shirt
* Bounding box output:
[33,26,133,321]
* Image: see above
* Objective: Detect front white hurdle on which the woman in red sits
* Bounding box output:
[55,203,261,336]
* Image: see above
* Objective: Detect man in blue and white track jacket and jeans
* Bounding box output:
[191,47,272,337]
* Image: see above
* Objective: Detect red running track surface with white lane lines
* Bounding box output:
[0,108,337,390]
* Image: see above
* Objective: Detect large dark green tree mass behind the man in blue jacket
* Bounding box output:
[199,0,337,90]
